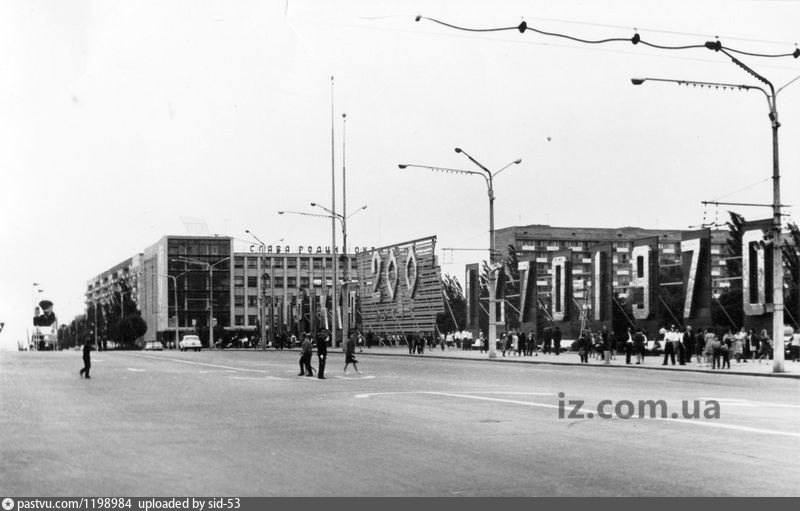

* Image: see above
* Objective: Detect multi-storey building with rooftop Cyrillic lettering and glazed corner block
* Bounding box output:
[86,236,359,345]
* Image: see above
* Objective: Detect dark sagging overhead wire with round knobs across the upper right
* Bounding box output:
[415,15,800,59]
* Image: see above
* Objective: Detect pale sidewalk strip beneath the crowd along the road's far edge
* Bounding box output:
[352,345,800,379]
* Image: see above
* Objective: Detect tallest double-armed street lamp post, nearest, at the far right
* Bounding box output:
[631,58,800,373]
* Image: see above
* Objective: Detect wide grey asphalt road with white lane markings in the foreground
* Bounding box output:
[0,350,800,497]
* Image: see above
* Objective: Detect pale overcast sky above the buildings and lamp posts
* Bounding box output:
[0,0,800,349]
